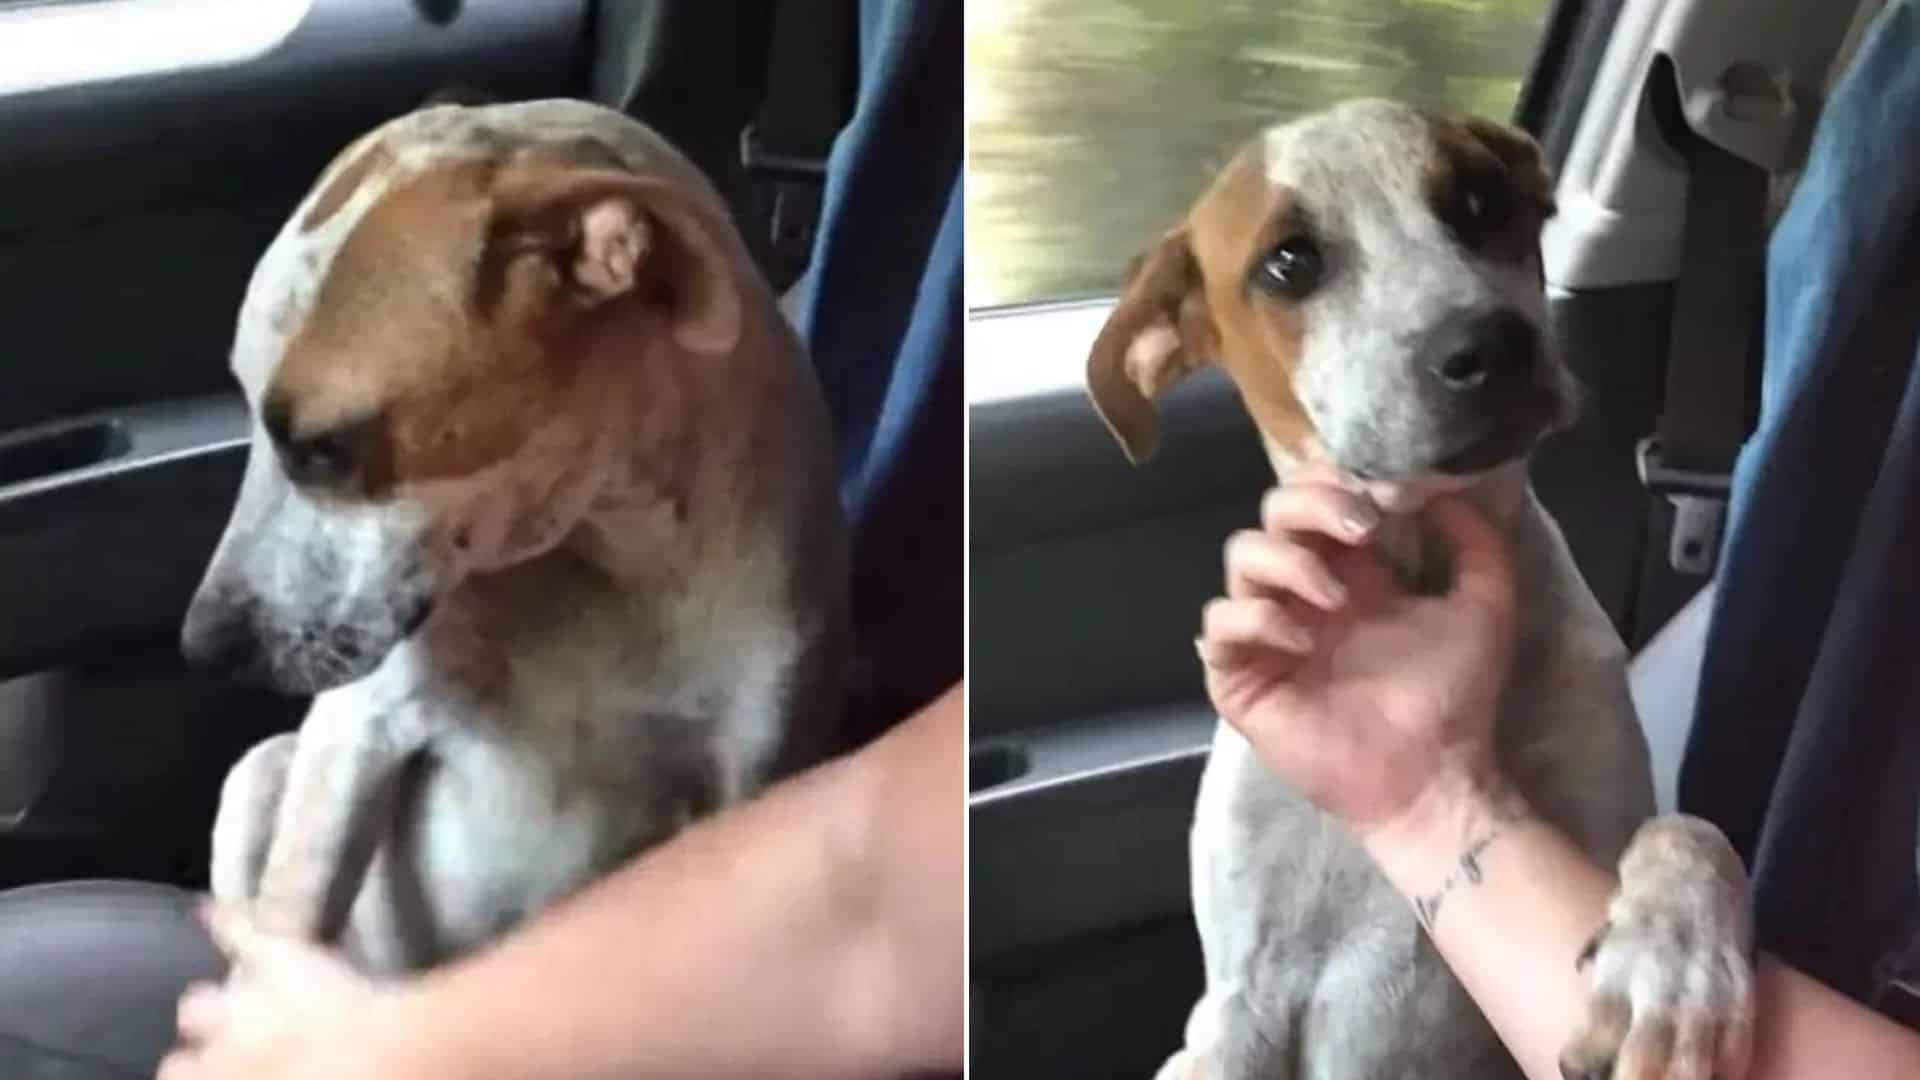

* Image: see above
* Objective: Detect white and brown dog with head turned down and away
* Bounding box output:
[182,100,849,972]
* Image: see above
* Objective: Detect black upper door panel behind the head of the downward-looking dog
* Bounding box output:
[0,0,586,430]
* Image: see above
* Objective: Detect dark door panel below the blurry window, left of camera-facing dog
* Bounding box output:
[968,371,1271,738]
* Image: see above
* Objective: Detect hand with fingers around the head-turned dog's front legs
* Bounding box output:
[156,905,434,1080]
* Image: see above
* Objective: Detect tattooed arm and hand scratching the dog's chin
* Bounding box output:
[1200,473,1920,1080]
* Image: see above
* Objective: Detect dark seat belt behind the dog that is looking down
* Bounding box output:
[739,0,856,292]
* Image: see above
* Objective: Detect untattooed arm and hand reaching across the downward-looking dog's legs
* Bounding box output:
[161,686,964,1080]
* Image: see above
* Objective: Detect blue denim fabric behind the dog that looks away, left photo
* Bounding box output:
[797,0,966,742]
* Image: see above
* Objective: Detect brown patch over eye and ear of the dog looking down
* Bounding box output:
[261,140,741,494]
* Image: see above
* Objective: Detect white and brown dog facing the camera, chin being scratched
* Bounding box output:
[1087,100,1751,1080]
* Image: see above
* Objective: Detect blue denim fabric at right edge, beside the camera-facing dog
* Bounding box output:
[1680,0,1920,1013]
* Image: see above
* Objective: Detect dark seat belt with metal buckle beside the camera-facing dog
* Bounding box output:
[1636,111,1770,588]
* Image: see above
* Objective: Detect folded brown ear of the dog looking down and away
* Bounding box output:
[492,161,741,354]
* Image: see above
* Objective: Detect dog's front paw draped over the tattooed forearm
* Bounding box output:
[1561,815,1753,1080]
